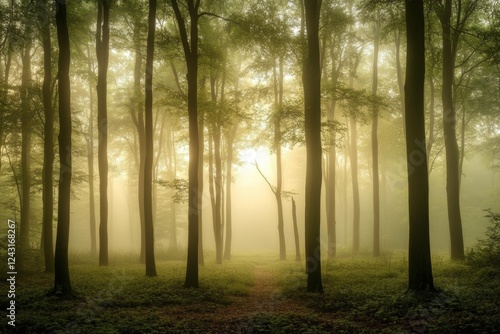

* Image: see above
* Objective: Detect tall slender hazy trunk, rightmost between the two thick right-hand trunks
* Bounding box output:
[372,21,381,257]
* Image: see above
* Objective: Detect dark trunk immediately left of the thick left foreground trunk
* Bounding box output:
[41,0,54,273]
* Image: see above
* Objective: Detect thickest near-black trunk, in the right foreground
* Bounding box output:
[405,0,434,291]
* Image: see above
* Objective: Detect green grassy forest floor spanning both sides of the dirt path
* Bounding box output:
[0,254,500,333]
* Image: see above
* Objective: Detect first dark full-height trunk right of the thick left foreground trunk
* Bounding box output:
[95,0,109,266]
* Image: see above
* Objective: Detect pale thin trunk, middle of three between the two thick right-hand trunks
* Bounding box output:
[349,116,360,255]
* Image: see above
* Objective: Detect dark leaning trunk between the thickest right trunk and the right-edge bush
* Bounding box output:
[441,0,464,260]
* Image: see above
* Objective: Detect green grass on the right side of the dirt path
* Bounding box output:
[279,255,500,333]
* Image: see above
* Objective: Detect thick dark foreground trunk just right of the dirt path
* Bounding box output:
[302,0,323,293]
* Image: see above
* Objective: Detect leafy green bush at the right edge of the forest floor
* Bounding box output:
[466,209,500,267]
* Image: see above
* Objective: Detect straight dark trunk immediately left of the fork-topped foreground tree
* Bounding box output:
[144,0,156,277]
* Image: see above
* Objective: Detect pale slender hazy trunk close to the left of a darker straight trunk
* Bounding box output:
[87,44,97,255]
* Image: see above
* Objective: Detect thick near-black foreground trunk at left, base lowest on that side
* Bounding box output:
[53,1,73,295]
